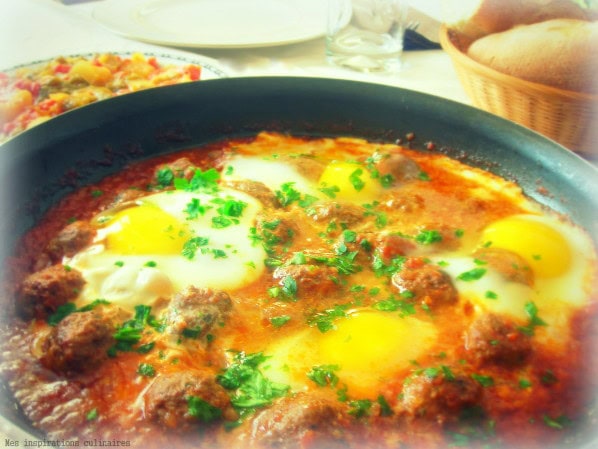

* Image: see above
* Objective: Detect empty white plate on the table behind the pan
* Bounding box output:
[93,0,327,48]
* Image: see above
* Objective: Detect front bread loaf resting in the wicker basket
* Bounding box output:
[467,19,598,93]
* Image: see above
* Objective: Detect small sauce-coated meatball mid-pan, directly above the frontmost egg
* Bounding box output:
[273,264,339,299]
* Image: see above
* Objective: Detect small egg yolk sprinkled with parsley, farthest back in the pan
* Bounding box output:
[320,161,381,203]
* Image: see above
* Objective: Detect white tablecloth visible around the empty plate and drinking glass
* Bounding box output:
[0,0,470,104]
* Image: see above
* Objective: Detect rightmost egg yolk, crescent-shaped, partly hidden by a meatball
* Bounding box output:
[482,216,571,278]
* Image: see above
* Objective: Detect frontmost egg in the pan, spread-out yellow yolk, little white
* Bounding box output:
[264,309,438,398]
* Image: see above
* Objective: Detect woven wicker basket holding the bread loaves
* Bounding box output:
[440,26,598,158]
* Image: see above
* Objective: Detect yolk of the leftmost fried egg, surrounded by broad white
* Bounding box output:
[101,204,189,254]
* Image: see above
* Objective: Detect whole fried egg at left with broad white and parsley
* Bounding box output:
[65,189,266,308]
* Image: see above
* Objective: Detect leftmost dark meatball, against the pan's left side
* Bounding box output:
[18,264,85,319]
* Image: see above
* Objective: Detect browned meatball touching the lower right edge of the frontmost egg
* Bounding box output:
[399,373,482,424]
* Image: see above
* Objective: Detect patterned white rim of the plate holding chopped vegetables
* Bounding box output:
[0,50,228,80]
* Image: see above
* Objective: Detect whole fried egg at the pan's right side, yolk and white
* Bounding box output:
[432,214,596,341]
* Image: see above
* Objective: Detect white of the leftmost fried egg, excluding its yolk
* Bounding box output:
[65,189,266,309]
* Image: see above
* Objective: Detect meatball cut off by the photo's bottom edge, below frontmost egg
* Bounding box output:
[250,393,347,449]
